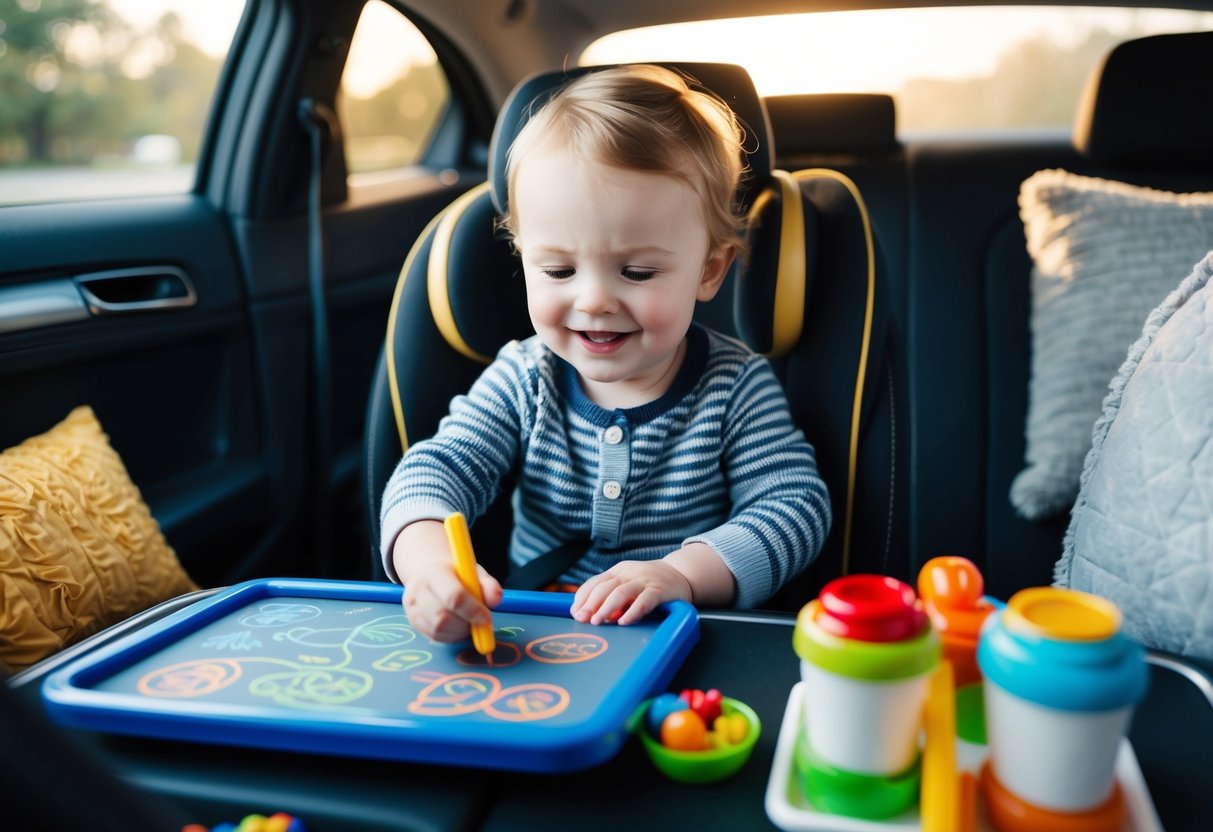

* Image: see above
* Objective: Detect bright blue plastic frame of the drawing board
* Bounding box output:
[42,579,699,773]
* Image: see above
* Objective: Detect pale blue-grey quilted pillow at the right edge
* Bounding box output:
[1054,252,1213,659]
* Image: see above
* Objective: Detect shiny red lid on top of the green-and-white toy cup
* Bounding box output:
[814,575,928,642]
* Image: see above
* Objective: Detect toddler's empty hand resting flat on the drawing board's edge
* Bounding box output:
[573,560,691,625]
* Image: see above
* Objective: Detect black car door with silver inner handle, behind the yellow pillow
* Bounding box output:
[0,4,274,583]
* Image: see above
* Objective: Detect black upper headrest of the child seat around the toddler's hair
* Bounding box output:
[489,63,774,213]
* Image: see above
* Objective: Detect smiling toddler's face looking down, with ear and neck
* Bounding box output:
[511,149,730,408]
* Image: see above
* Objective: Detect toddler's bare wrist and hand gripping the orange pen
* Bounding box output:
[392,520,501,642]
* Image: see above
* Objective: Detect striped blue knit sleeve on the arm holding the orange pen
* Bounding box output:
[380,342,536,580]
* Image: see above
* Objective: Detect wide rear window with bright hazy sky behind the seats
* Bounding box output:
[581,6,1213,133]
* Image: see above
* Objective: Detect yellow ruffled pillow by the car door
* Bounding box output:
[0,406,198,671]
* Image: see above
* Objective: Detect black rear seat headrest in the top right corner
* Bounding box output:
[1074,32,1213,167]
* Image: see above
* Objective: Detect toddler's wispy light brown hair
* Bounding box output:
[500,64,745,255]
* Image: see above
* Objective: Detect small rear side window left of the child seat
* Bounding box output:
[337,0,450,187]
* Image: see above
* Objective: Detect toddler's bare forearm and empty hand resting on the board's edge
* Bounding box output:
[573,543,736,625]
